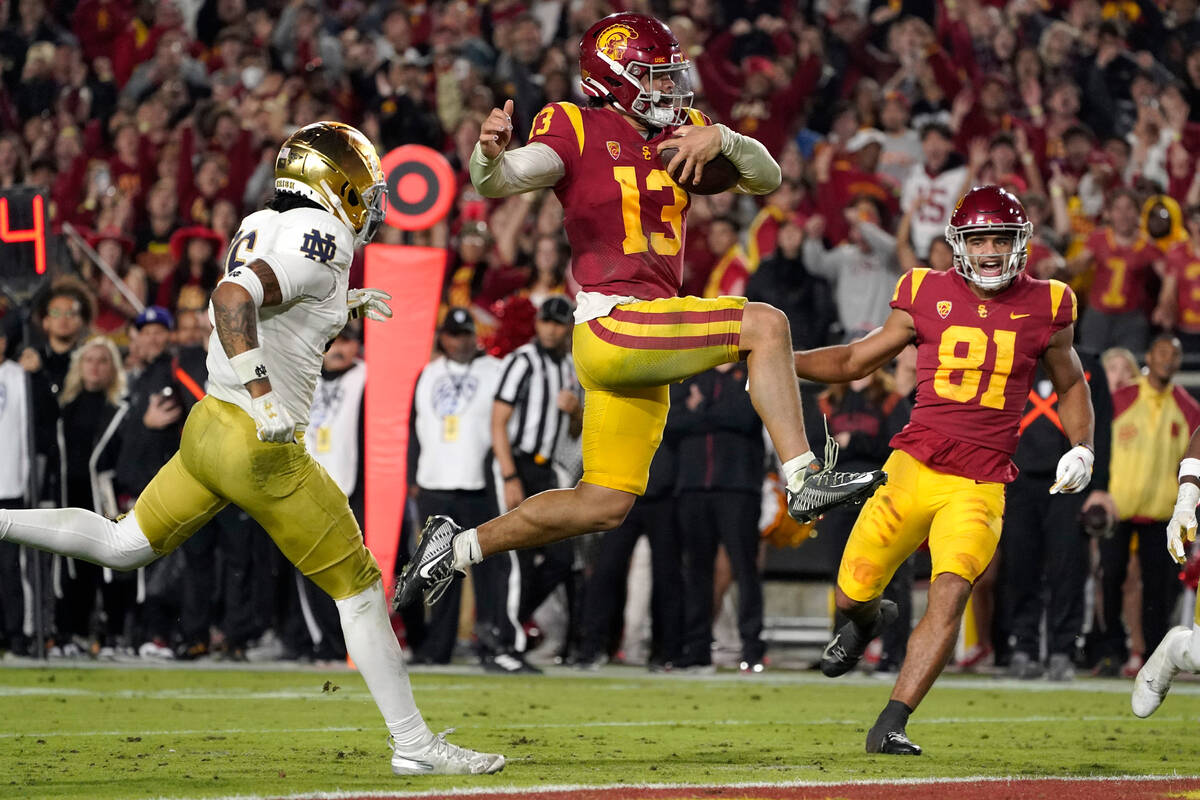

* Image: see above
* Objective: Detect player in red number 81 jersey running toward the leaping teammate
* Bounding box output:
[796,186,1094,756]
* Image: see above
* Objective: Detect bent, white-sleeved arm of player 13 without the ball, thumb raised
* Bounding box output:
[468,100,566,198]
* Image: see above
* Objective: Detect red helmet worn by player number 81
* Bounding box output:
[946,186,1033,289]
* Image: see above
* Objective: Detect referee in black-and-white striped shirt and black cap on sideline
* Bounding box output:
[476,295,583,672]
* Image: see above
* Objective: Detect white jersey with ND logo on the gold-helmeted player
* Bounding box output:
[208,209,354,431]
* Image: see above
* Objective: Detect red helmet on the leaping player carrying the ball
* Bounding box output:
[580,13,692,128]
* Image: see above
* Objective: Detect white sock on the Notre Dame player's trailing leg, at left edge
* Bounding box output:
[0,509,158,570]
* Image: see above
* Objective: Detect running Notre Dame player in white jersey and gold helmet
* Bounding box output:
[0,122,504,775]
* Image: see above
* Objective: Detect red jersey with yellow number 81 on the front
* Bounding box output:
[892,269,1076,483]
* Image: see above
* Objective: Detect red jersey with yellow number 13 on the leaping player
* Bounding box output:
[529,103,708,300]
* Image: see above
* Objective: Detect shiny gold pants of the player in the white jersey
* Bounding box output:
[133,397,380,600]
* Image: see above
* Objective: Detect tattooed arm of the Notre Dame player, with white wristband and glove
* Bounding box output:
[212,260,295,443]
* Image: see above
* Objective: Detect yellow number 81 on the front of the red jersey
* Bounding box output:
[934,325,1016,409]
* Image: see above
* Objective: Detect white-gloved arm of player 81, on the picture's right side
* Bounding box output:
[1042,325,1096,494]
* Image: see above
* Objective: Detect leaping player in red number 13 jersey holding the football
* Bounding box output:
[397,13,886,606]
